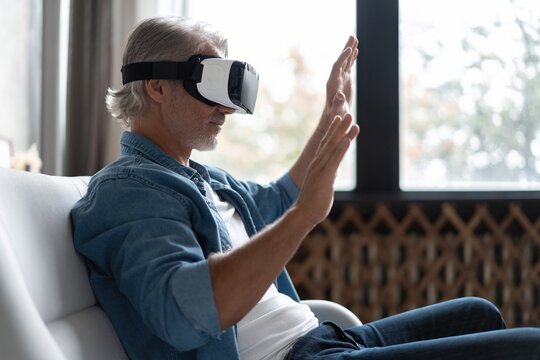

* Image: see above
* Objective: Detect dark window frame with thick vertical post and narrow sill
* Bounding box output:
[336,0,540,201]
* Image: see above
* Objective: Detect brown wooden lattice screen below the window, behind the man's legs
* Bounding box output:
[288,203,540,326]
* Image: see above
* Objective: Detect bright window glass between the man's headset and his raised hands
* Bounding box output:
[187,0,356,190]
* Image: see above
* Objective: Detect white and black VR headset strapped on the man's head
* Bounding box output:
[122,55,259,114]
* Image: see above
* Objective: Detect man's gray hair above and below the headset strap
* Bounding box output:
[105,17,227,127]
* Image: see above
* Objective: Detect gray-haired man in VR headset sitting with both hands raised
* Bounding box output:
[72,18,540,359]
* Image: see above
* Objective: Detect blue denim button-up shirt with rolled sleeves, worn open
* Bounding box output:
[71,132,299,360]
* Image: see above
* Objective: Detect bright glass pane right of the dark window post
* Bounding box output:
[400,0,540,190]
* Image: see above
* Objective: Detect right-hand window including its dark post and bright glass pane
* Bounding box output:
[355,0,540,200]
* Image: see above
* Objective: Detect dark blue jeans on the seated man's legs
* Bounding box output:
[286,298,540,360]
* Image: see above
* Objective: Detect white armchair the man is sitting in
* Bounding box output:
[0,168,361,360]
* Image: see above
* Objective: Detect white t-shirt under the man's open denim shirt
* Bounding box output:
[204,182,319,360]
